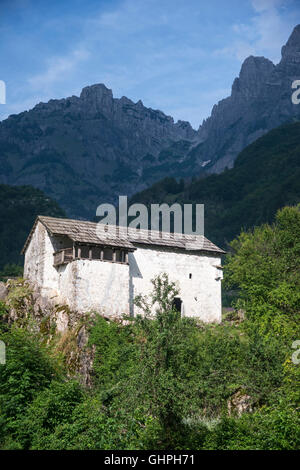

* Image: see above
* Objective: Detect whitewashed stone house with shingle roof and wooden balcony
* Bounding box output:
[22,216,224,322]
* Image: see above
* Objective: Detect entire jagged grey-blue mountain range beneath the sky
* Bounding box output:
[0,25,300,218]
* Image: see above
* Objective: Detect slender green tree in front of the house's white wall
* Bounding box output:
[130,274,207,448]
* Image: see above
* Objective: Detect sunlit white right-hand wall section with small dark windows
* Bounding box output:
[129,246,222,322]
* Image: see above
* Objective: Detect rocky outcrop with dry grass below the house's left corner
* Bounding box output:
[0,279,95,386]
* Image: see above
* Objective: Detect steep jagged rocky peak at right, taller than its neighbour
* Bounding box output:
[194,25,300,173]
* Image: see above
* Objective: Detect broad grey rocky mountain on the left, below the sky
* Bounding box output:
[0,84,197,217]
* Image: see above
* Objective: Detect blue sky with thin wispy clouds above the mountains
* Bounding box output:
[0,0,300,128]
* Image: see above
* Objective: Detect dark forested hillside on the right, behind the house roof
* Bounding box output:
[131,122,300,249]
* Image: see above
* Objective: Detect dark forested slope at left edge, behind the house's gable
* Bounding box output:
[0,184,65,270]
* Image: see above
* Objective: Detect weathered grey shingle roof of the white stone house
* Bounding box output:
[22,216,225,254]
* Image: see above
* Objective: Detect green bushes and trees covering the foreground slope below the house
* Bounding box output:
[0,205,300,450]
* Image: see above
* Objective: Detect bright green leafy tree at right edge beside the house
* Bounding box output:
[225,205,300,341]
